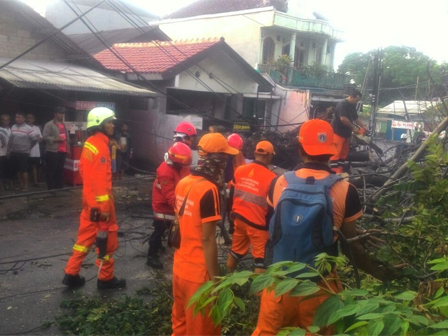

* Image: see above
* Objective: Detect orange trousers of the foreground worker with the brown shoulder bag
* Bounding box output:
[171,274,221,336]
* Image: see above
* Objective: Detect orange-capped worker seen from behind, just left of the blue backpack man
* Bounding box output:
[227,141,277,273]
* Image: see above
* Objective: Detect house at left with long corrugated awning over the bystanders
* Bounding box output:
[0,0,157,173]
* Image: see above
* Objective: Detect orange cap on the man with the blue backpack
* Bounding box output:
[299,119,337,155]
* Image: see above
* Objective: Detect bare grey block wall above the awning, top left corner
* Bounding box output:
[0,2,65,61]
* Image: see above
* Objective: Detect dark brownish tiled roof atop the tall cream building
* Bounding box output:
[164,0,275,19]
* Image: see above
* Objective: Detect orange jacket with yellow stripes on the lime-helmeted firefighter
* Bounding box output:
[79,132,118,231]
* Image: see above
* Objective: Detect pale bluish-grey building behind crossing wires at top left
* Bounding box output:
[45,0,159,35]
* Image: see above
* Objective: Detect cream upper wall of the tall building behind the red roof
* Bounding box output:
[159,10,274,67]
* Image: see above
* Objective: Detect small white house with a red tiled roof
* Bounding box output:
[95,38,281,167]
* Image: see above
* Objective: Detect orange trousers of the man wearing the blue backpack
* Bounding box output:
[252,274,342,336]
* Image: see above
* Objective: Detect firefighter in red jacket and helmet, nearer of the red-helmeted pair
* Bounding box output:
[146,142,193,269]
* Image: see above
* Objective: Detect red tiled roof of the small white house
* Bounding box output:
[95,38,223,73]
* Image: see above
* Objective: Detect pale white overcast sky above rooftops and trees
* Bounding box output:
[21,0,448,66]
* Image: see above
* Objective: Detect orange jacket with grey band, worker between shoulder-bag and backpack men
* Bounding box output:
[231,161,277,230]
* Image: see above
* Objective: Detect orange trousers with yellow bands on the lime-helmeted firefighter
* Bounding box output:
[65,208,118,281]
